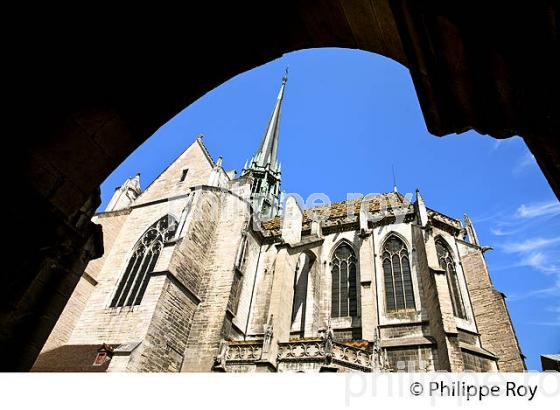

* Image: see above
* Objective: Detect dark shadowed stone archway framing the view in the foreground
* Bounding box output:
[4,0,560,370]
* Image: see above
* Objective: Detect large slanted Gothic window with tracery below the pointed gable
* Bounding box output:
[109,215,177,307]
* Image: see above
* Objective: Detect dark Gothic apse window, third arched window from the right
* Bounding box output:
[331,243,358,317]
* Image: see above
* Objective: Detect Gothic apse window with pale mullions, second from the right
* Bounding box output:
[383,235,416,312]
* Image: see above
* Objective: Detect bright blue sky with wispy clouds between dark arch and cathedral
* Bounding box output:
[100,49,560,370]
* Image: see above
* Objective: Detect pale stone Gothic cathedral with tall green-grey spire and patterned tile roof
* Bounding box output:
[33,76,525,372]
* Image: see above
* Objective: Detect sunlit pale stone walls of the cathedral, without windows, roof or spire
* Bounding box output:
[32,159,519,372]
